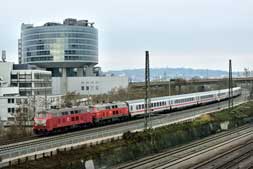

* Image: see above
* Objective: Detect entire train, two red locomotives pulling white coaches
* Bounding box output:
[33,87,241,135]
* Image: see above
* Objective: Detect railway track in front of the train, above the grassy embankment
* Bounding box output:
[0,95,247,162]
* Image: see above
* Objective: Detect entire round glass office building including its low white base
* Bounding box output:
[18,18,128,95]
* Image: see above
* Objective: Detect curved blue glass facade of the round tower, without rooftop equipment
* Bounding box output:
[21,24,98,67]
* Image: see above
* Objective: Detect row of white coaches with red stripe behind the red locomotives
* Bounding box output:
[127,87,241,116]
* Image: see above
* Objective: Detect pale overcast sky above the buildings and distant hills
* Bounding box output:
[0,0,253,70]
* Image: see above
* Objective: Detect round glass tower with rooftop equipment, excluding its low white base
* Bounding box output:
[19,18,98,77]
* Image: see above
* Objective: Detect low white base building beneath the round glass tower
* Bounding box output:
[52,76,128,95]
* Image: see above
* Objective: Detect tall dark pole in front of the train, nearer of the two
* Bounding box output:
[144,51,151,129]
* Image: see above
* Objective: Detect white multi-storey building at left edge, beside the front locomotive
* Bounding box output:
[0,62,58,121]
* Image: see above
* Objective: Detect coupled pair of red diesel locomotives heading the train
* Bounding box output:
[33,103,129,135]
